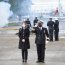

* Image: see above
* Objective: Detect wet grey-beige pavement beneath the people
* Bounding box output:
[0,34,65,65]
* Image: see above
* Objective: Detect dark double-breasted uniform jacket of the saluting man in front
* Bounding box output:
[35,27,49,45]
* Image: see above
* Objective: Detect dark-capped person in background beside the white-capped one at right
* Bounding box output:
[47,18,54,41]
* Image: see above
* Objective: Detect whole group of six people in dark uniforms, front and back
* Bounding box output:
[18,17,59,63]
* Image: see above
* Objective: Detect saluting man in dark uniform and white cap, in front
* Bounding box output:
[34,21,49,63]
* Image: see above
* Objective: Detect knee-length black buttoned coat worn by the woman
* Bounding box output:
[19,28,30,49]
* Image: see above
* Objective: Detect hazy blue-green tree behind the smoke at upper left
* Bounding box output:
[9,0,32,16]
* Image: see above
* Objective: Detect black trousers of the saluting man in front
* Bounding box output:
[36,44,45,61]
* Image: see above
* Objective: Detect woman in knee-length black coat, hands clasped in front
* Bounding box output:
[19,22,30,62]
